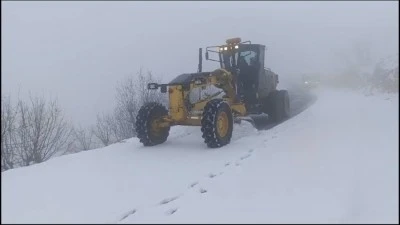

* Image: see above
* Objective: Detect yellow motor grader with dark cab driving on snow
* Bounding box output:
[136,38,290,148]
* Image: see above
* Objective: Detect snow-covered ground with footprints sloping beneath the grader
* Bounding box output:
[1,87,399,223]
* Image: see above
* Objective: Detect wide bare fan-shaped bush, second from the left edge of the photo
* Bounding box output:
[17,96,71,166]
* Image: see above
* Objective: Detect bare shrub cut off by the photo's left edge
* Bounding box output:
[1,96,17,171]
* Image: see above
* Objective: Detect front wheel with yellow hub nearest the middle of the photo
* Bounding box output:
[201,99,233,148]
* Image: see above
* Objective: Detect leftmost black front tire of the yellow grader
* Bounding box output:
[136,102,170,146]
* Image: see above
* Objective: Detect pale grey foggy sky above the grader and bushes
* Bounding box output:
[1,1,399,125]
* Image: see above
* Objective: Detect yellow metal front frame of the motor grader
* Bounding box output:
[156,69,247,128]
